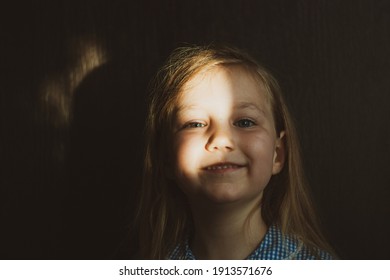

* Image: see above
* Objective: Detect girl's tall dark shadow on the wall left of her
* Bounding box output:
[64,62,145,259]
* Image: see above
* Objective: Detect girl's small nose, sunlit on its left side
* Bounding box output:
[206,124,234,152]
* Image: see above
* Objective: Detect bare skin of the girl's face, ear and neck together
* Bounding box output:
[173,66,284,259]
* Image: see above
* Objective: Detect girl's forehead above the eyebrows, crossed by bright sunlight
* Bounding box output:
[178,65,270,110]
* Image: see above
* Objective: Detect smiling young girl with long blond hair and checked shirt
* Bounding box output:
[138,46,332,259]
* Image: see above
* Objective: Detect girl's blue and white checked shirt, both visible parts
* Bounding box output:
[168,225,333,260]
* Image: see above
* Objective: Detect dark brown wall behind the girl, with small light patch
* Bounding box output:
[0,0,390,259]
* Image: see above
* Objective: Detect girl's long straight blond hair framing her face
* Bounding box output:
[137,45,332,259]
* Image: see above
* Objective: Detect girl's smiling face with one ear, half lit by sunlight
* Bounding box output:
[173,66,284,206]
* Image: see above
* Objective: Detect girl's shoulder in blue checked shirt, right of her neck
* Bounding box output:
[248,225,333,260]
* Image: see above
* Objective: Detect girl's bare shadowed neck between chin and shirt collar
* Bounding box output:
[190,198,267,259]
